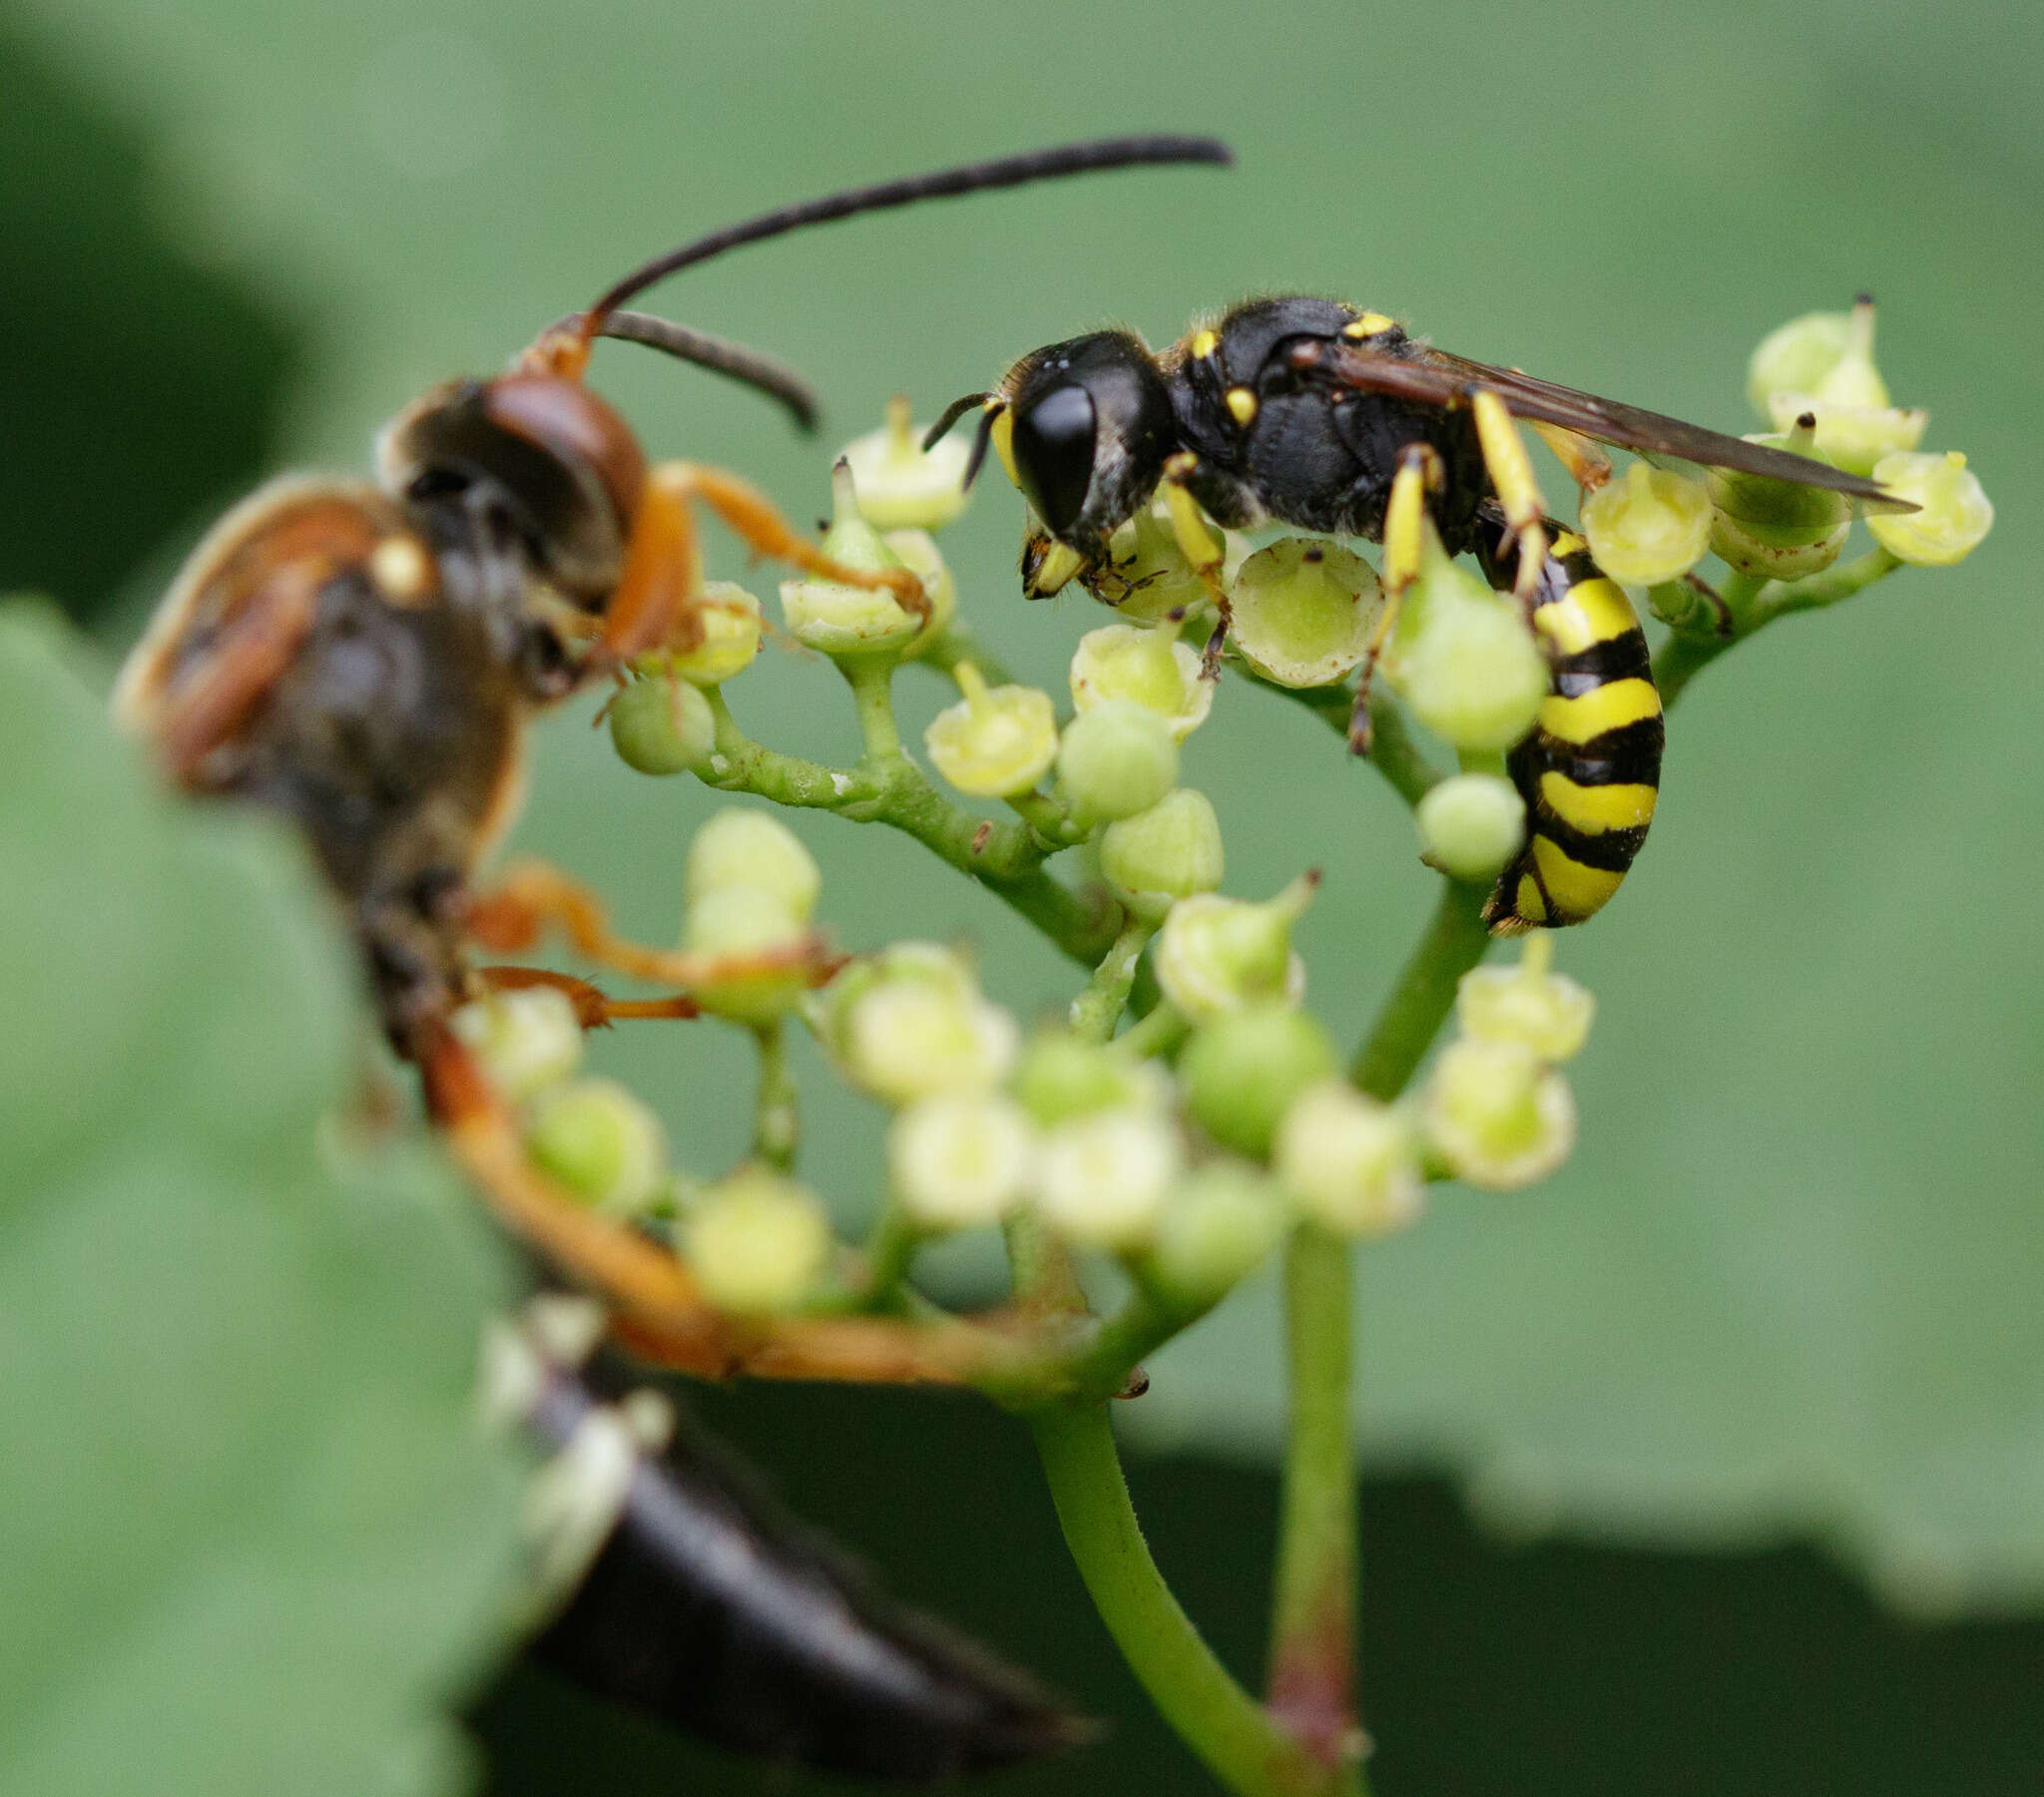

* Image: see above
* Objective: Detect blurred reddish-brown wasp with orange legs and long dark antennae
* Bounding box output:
[115,137,1229,1779]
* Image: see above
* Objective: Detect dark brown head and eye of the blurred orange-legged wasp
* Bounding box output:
[376,374,646,610]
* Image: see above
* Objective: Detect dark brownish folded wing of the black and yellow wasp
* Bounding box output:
[1293,341,1915,515]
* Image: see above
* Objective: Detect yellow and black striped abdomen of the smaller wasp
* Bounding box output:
[1484,550,1664,934]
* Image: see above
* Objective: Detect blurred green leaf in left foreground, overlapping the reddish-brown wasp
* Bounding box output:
[0,608,517,1797]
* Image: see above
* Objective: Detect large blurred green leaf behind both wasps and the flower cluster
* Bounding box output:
[23,0,2044,1608]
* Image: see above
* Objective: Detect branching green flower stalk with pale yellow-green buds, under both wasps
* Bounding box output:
[511,330,1993,1797]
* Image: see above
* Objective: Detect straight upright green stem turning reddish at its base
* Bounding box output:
[1270,1222,1361,1764]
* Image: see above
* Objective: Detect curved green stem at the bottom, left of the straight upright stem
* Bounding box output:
[1030,1405,1343,1797]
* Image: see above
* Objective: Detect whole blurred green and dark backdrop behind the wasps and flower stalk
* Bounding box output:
[0,0,2044,1797]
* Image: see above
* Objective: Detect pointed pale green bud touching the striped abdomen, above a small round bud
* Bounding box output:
[1383,526,1547,750]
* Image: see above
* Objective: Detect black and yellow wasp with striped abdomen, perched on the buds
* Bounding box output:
[930,296,1903,932]
